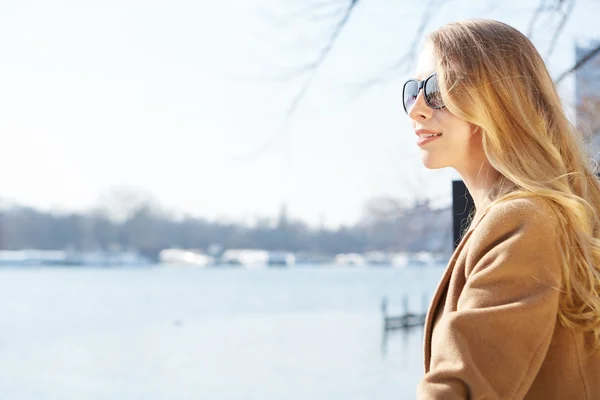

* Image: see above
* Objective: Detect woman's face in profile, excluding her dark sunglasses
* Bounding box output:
[408,45,486,175]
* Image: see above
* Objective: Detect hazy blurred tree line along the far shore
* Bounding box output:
[0,198,452,259]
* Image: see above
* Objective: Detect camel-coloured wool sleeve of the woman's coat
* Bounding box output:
[417,200,562,400]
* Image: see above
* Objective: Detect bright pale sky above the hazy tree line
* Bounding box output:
[0,0,600,227]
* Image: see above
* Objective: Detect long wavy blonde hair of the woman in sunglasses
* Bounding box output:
[429,20,600,344]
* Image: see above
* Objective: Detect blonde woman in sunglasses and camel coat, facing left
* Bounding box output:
[403,20,600,400]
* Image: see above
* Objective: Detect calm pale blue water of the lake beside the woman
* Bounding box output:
[0,268,442,400]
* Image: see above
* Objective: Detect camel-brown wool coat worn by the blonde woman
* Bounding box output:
[417,199,600,400]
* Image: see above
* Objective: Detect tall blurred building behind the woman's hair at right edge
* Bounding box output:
[575,40,600,161]
